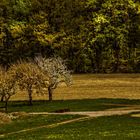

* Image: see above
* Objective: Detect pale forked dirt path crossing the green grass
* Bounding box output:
[0,106,140,137]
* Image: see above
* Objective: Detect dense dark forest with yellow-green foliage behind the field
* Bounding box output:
[0,0,140,73]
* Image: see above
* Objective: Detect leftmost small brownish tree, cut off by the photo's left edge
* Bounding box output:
[0,67,16,111]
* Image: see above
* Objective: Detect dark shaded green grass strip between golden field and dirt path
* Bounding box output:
[0,98,140,112]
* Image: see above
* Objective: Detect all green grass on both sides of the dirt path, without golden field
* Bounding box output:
[0,99,140,140]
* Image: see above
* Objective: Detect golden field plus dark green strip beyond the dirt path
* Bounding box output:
[0,74,140,112]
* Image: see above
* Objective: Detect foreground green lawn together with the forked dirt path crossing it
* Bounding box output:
[0,107,140,140]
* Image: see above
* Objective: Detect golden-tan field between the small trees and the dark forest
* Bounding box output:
[11,74,140,100]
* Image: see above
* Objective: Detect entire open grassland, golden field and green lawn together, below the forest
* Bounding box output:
[0,74,140,140]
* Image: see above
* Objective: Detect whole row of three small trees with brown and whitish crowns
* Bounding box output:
[0,57,71,110]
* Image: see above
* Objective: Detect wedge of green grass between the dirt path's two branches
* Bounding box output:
[0,115,80,140]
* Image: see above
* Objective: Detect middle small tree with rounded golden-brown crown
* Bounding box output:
[11,61,46,105]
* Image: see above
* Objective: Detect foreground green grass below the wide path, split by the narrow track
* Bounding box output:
[0,115,140,140]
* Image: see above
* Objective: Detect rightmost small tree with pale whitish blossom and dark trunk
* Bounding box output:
[35,57,72,101]
